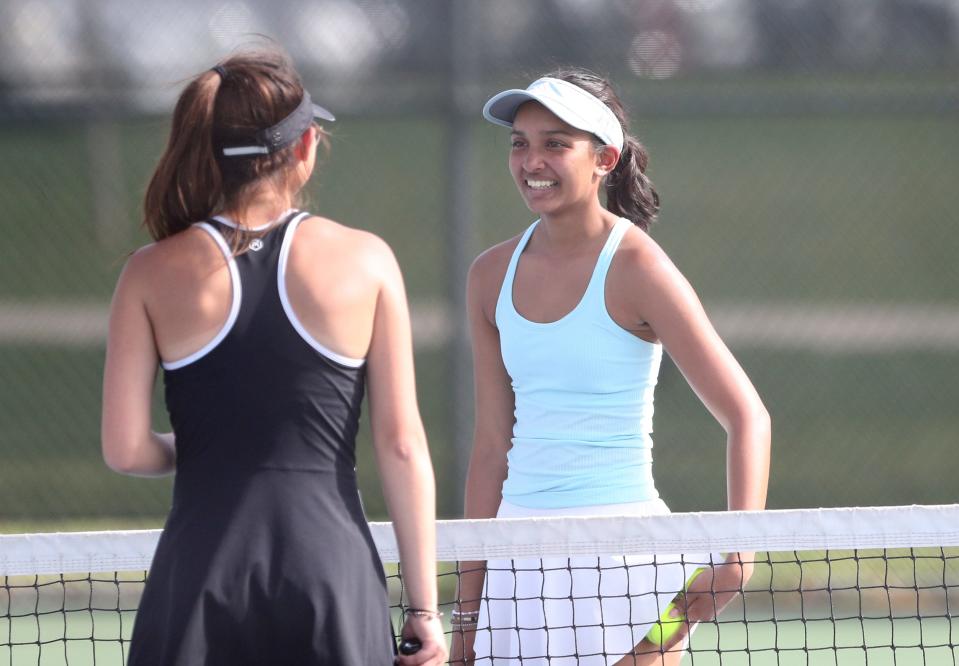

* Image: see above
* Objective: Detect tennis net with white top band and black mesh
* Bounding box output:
[0,505,959,666]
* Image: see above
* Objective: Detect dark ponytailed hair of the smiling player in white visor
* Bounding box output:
[546,67,659,231]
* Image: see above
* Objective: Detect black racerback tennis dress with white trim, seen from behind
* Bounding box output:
[128,211,394,666]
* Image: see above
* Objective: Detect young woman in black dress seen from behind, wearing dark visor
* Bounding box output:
[102,51,446,666]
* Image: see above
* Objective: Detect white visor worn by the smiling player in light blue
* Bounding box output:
[483,77,623,152]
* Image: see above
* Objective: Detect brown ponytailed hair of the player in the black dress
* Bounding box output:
[143,49,325,240]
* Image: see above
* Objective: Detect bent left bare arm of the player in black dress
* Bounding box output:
[100,255,176,476]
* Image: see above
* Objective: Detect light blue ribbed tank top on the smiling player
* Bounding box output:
[496,219,662,508]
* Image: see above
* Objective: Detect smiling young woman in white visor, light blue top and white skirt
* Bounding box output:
[452,69,770,666]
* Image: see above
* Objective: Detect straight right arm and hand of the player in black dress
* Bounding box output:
[367,245,446,664]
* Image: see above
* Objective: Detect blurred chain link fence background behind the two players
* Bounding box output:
[0,0,959,530]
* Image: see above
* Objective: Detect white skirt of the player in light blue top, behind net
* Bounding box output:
[474,499,710,666]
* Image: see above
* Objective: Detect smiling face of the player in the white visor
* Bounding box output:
[509,102,608,215]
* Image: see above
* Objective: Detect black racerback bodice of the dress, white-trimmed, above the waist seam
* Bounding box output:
[163,212,365,479]
